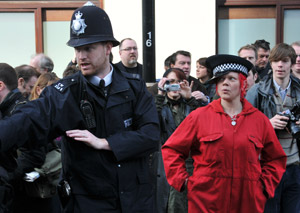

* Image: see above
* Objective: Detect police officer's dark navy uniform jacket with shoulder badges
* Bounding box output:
[0,66,159,212]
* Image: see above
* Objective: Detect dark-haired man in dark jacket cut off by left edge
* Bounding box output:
[0,63,46,212]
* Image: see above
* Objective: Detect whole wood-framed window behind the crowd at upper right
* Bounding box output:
[216,0,300,55]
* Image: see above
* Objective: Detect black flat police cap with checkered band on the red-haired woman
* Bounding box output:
[206,54,253,84]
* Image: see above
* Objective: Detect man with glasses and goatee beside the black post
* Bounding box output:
[116,38,143,78]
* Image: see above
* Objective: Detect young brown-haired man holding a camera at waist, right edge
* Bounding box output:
[246,43,300,213]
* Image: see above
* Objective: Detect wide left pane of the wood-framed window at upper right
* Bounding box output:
[218,7,276,55]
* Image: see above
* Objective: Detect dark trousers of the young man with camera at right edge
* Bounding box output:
[264,164,300,213]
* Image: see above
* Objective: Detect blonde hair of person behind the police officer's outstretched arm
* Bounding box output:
[30,72,60,100]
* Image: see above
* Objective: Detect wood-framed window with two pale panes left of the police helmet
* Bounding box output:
[0,0,103,77]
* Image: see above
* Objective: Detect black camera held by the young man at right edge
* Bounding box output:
[278,102,300,139]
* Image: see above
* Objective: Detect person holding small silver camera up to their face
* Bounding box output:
[153,68,199,213]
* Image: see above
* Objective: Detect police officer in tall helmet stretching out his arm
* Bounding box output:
[0,3,159,213]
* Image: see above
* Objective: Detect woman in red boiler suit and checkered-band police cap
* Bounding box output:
[162,55,286,213]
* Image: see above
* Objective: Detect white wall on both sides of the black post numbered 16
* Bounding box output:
[104,0,216,78]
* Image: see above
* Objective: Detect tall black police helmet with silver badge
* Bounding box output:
[67,2,119,47]
